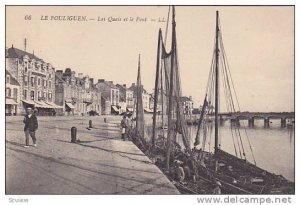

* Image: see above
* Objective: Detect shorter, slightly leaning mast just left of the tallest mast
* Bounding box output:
[152,29,161,148]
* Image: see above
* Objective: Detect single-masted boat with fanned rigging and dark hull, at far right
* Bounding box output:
[189,11,294,194]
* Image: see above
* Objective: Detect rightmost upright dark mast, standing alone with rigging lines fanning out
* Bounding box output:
[215,11,219,171]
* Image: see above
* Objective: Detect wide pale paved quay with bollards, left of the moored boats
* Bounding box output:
[6,116,179,195]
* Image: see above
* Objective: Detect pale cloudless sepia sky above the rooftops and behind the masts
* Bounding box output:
[6,6,294,112]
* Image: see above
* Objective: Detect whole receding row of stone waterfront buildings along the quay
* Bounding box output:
[5,45,192,115]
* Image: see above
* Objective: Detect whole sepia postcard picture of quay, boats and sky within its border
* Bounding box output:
[2,5,295,203]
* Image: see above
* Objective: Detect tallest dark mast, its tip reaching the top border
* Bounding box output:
[166,6,176,170]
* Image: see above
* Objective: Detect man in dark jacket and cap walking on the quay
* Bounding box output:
[23,107,38,148]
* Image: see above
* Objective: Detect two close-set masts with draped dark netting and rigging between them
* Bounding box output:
[152,6,190,172]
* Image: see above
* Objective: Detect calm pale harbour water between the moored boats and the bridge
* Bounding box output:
[146,114,295,181]
